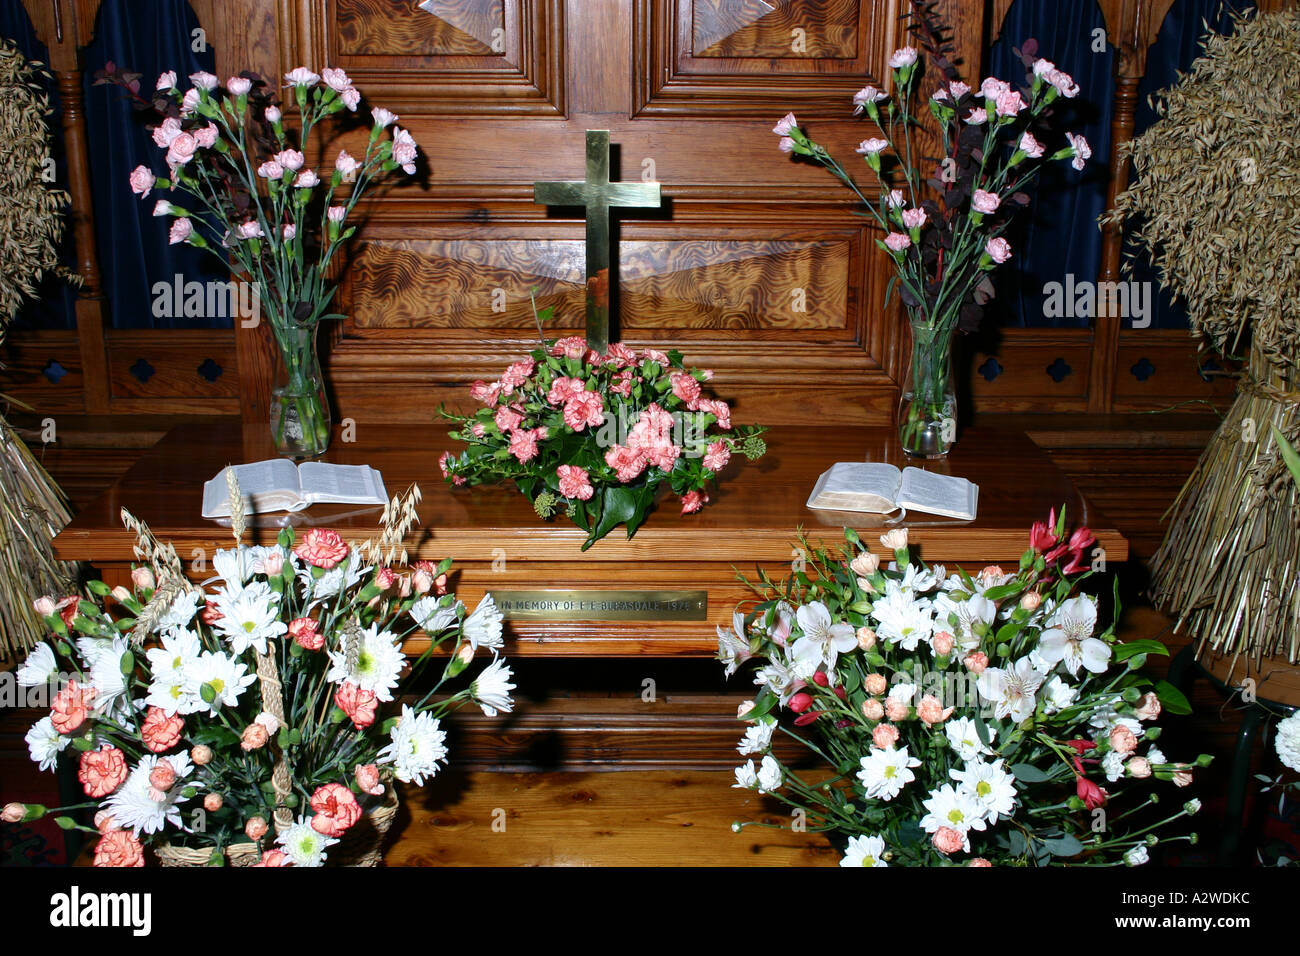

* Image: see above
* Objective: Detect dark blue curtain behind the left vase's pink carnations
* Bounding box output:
[83,0,231,329]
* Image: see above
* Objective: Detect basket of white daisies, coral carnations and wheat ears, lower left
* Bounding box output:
[3,470,514,866]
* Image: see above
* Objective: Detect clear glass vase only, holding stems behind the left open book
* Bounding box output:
[270,323,332,459]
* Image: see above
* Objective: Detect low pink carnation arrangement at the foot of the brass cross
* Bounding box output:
[438,310,767,551]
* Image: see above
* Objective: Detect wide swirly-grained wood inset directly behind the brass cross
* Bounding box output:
[350,239,853,336]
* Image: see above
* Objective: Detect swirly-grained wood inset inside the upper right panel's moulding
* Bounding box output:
[690,0,862,60]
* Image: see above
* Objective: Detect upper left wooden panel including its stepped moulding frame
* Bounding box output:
[318,0,564,117]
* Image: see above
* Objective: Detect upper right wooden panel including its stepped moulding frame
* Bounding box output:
[632,0,901,118]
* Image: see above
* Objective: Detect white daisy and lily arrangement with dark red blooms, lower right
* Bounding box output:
[718,514,1209,866]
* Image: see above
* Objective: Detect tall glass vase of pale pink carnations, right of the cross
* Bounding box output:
[772,0,1092,458]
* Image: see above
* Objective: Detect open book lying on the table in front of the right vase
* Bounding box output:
[809,462,979,520]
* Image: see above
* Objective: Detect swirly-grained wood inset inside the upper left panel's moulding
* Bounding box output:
[334,0,506,56]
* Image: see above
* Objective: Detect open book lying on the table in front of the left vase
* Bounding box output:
[203,458,389,518]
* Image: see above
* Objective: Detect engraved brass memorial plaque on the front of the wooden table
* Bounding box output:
[491,589,709,620]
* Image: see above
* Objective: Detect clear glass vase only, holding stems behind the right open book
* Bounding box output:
[898,320,957,459]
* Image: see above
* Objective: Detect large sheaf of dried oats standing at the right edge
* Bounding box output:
[1104,10,1300,676]
